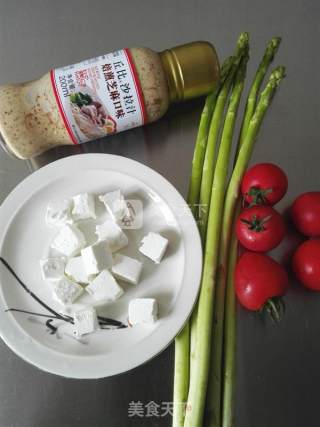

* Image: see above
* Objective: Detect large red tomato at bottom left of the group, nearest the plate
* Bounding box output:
[234,252,289,311]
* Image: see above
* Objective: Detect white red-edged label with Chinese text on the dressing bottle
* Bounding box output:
[50,49,146,144]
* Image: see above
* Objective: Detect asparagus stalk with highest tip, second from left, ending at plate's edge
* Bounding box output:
[200,33,249,240]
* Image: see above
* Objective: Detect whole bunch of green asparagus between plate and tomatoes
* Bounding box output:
[173,33,285,427]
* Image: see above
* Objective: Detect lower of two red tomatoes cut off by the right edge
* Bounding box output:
[292,239,320,291]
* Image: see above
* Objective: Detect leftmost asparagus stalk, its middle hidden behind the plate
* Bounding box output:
[173,57,233,427]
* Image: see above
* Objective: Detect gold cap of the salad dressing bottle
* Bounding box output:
[160,41,220,102]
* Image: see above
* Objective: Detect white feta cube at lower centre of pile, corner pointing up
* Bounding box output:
[86,270,123,302]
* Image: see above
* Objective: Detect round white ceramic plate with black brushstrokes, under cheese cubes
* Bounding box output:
[0,154,202,378]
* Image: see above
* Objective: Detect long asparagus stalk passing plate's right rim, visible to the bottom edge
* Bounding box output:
[185,45,248,427]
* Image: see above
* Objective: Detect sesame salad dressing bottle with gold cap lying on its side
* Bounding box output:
[0,42,220,159]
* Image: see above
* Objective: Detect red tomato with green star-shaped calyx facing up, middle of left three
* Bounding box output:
[236,206,286,252]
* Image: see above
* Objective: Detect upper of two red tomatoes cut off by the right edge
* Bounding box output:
[291,191,320,237]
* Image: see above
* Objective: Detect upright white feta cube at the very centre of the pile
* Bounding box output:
[81,240,113,275]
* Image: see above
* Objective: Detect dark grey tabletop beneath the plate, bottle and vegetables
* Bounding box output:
[0,0,320,427]
